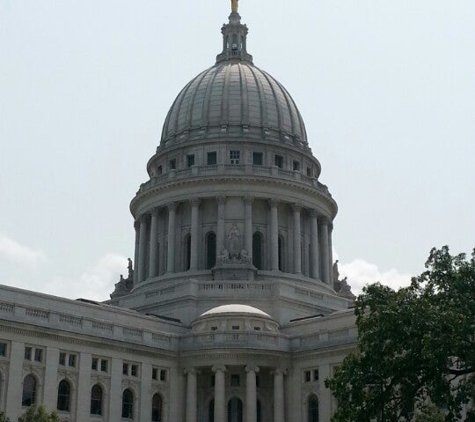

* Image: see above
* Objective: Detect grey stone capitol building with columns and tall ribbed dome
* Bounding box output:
[0,2,357,422]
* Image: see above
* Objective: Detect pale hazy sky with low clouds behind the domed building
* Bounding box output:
[0,0,475,300]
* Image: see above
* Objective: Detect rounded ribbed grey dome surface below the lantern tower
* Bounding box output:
[162,61,307,146]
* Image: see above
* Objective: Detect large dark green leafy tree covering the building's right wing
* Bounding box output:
[326,246,475,422]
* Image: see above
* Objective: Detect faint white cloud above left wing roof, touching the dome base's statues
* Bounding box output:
[42,254,127,301]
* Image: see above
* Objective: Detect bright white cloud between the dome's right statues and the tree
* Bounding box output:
[338,259,412,295]
